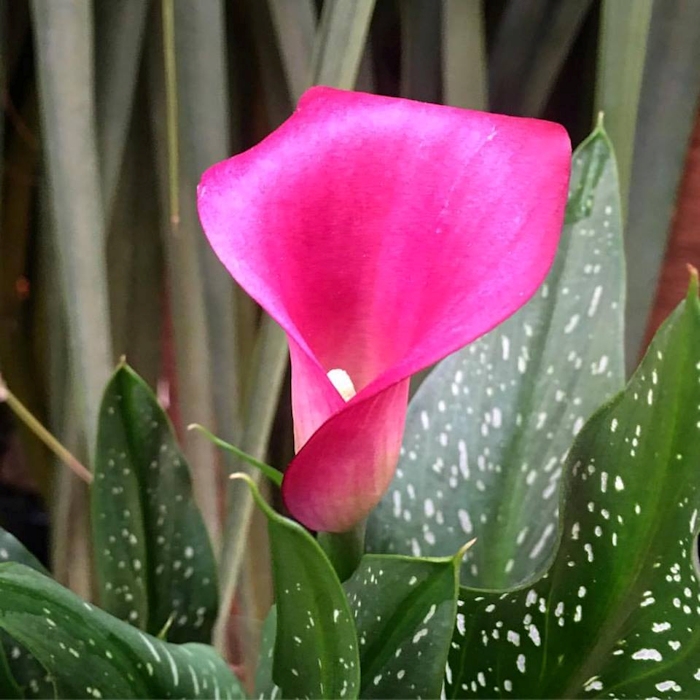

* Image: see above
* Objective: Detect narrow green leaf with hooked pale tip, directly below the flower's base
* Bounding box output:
[240,474,360,698]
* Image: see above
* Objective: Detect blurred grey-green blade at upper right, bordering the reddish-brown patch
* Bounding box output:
[625,0,700,373]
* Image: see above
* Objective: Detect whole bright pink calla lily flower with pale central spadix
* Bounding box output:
[198,87,571,532]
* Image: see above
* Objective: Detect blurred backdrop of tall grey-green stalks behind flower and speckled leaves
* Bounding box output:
[0,0,700,680]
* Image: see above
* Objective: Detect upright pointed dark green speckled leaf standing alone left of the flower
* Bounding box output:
[91,365,218,642]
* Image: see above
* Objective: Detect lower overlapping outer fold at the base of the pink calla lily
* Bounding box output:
[282,379,409,532]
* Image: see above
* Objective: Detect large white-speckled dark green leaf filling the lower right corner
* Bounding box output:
[447,276,700,698]
